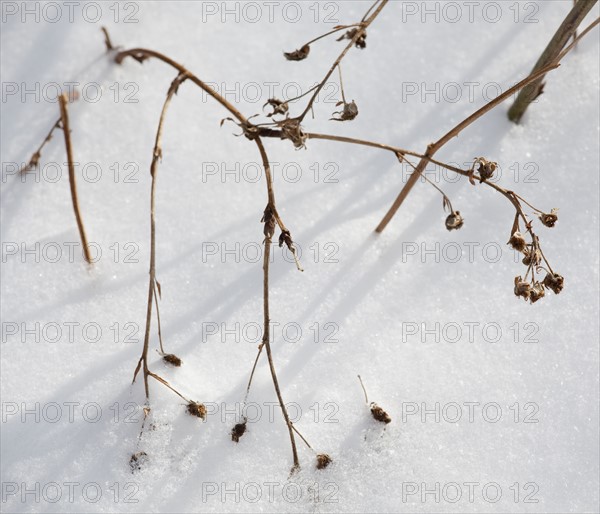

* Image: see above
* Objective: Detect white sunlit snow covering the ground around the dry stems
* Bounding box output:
[0,1,600,512]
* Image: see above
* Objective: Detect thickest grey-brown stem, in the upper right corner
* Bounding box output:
[508,0,598,123]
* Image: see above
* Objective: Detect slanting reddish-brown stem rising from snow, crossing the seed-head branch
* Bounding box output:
[375,63,560,233]
